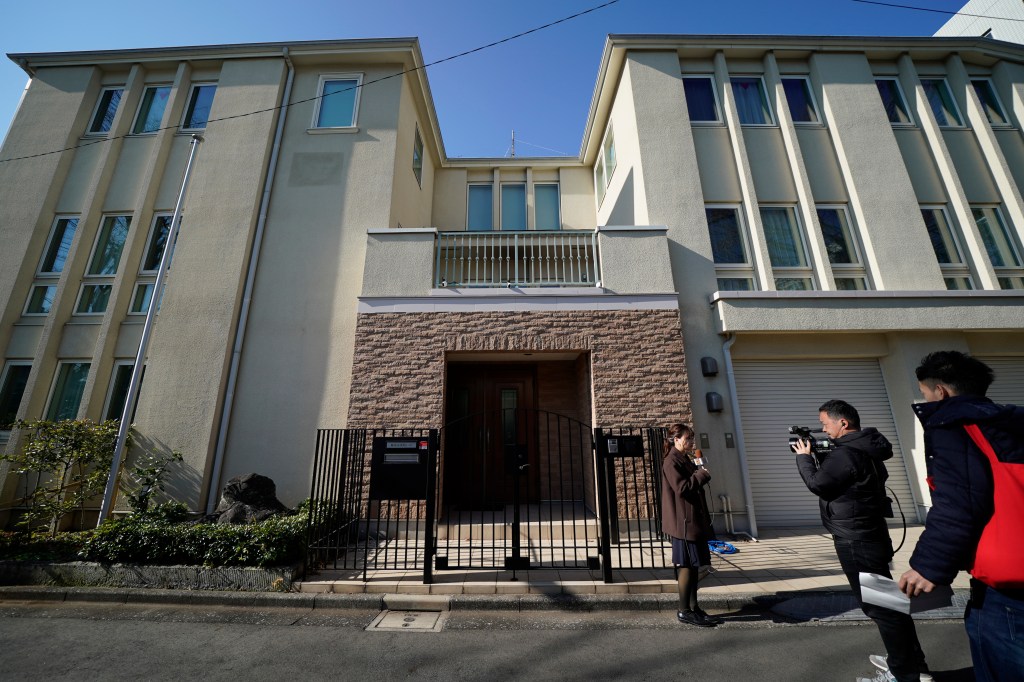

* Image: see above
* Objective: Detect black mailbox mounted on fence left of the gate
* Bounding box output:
[370,436,430,500]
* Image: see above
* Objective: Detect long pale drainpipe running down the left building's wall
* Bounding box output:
[206,47,295,514]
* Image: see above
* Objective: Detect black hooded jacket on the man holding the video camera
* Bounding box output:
[797,428,893,542]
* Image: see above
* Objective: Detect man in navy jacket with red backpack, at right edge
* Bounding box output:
[899,350,1024,682]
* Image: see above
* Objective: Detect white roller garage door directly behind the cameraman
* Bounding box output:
[734,359,916,527]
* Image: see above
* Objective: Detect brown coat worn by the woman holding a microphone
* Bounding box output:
[662,447,712,542]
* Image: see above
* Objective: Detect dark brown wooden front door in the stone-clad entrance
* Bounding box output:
[441,364,538,510]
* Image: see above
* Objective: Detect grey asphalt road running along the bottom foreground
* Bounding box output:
[0,602,974,682]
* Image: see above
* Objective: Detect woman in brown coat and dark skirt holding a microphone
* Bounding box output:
[662,424,722,628]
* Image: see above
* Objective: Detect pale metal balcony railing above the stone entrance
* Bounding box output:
[434,230,601,287]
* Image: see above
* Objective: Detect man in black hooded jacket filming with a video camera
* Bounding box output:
[792,400,932,682]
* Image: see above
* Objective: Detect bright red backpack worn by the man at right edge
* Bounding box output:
[964,424,1024,589]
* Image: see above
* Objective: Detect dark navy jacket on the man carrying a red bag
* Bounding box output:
[910,395,1024,585]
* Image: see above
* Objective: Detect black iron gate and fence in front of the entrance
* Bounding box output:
[307,409,671,583]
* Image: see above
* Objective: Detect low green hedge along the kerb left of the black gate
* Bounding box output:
[0,504,308,567]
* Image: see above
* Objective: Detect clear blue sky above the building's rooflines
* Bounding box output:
[0,0,965,158]
